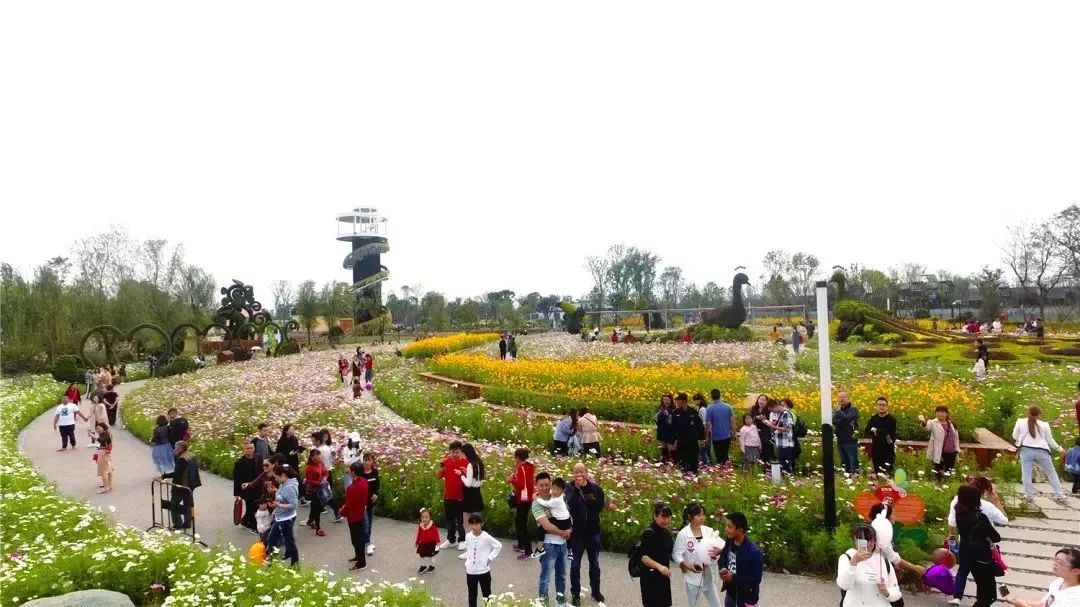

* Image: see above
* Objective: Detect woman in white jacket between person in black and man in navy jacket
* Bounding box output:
[672,502,724,607]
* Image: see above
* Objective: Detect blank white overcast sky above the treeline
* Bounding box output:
[0,0,1080,300]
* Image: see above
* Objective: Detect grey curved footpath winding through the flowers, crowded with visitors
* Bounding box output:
[18,381,1045,607]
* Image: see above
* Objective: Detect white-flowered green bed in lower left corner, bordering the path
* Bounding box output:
[0,376,431,607]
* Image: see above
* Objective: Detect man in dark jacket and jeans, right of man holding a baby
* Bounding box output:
[566,462,607,606]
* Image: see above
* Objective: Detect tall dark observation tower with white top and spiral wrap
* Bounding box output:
[337,206,390,323]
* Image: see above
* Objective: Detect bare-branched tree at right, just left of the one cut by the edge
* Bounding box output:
[1002,221,1069,318]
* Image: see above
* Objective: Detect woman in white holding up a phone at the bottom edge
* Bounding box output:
[836,525,901,607]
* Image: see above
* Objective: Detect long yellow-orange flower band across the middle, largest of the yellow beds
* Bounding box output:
[425,353,746,402]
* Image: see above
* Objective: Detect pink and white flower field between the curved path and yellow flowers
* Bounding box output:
[118,352,972,572]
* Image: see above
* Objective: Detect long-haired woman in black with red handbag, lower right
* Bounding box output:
[955,485,1001,607]
